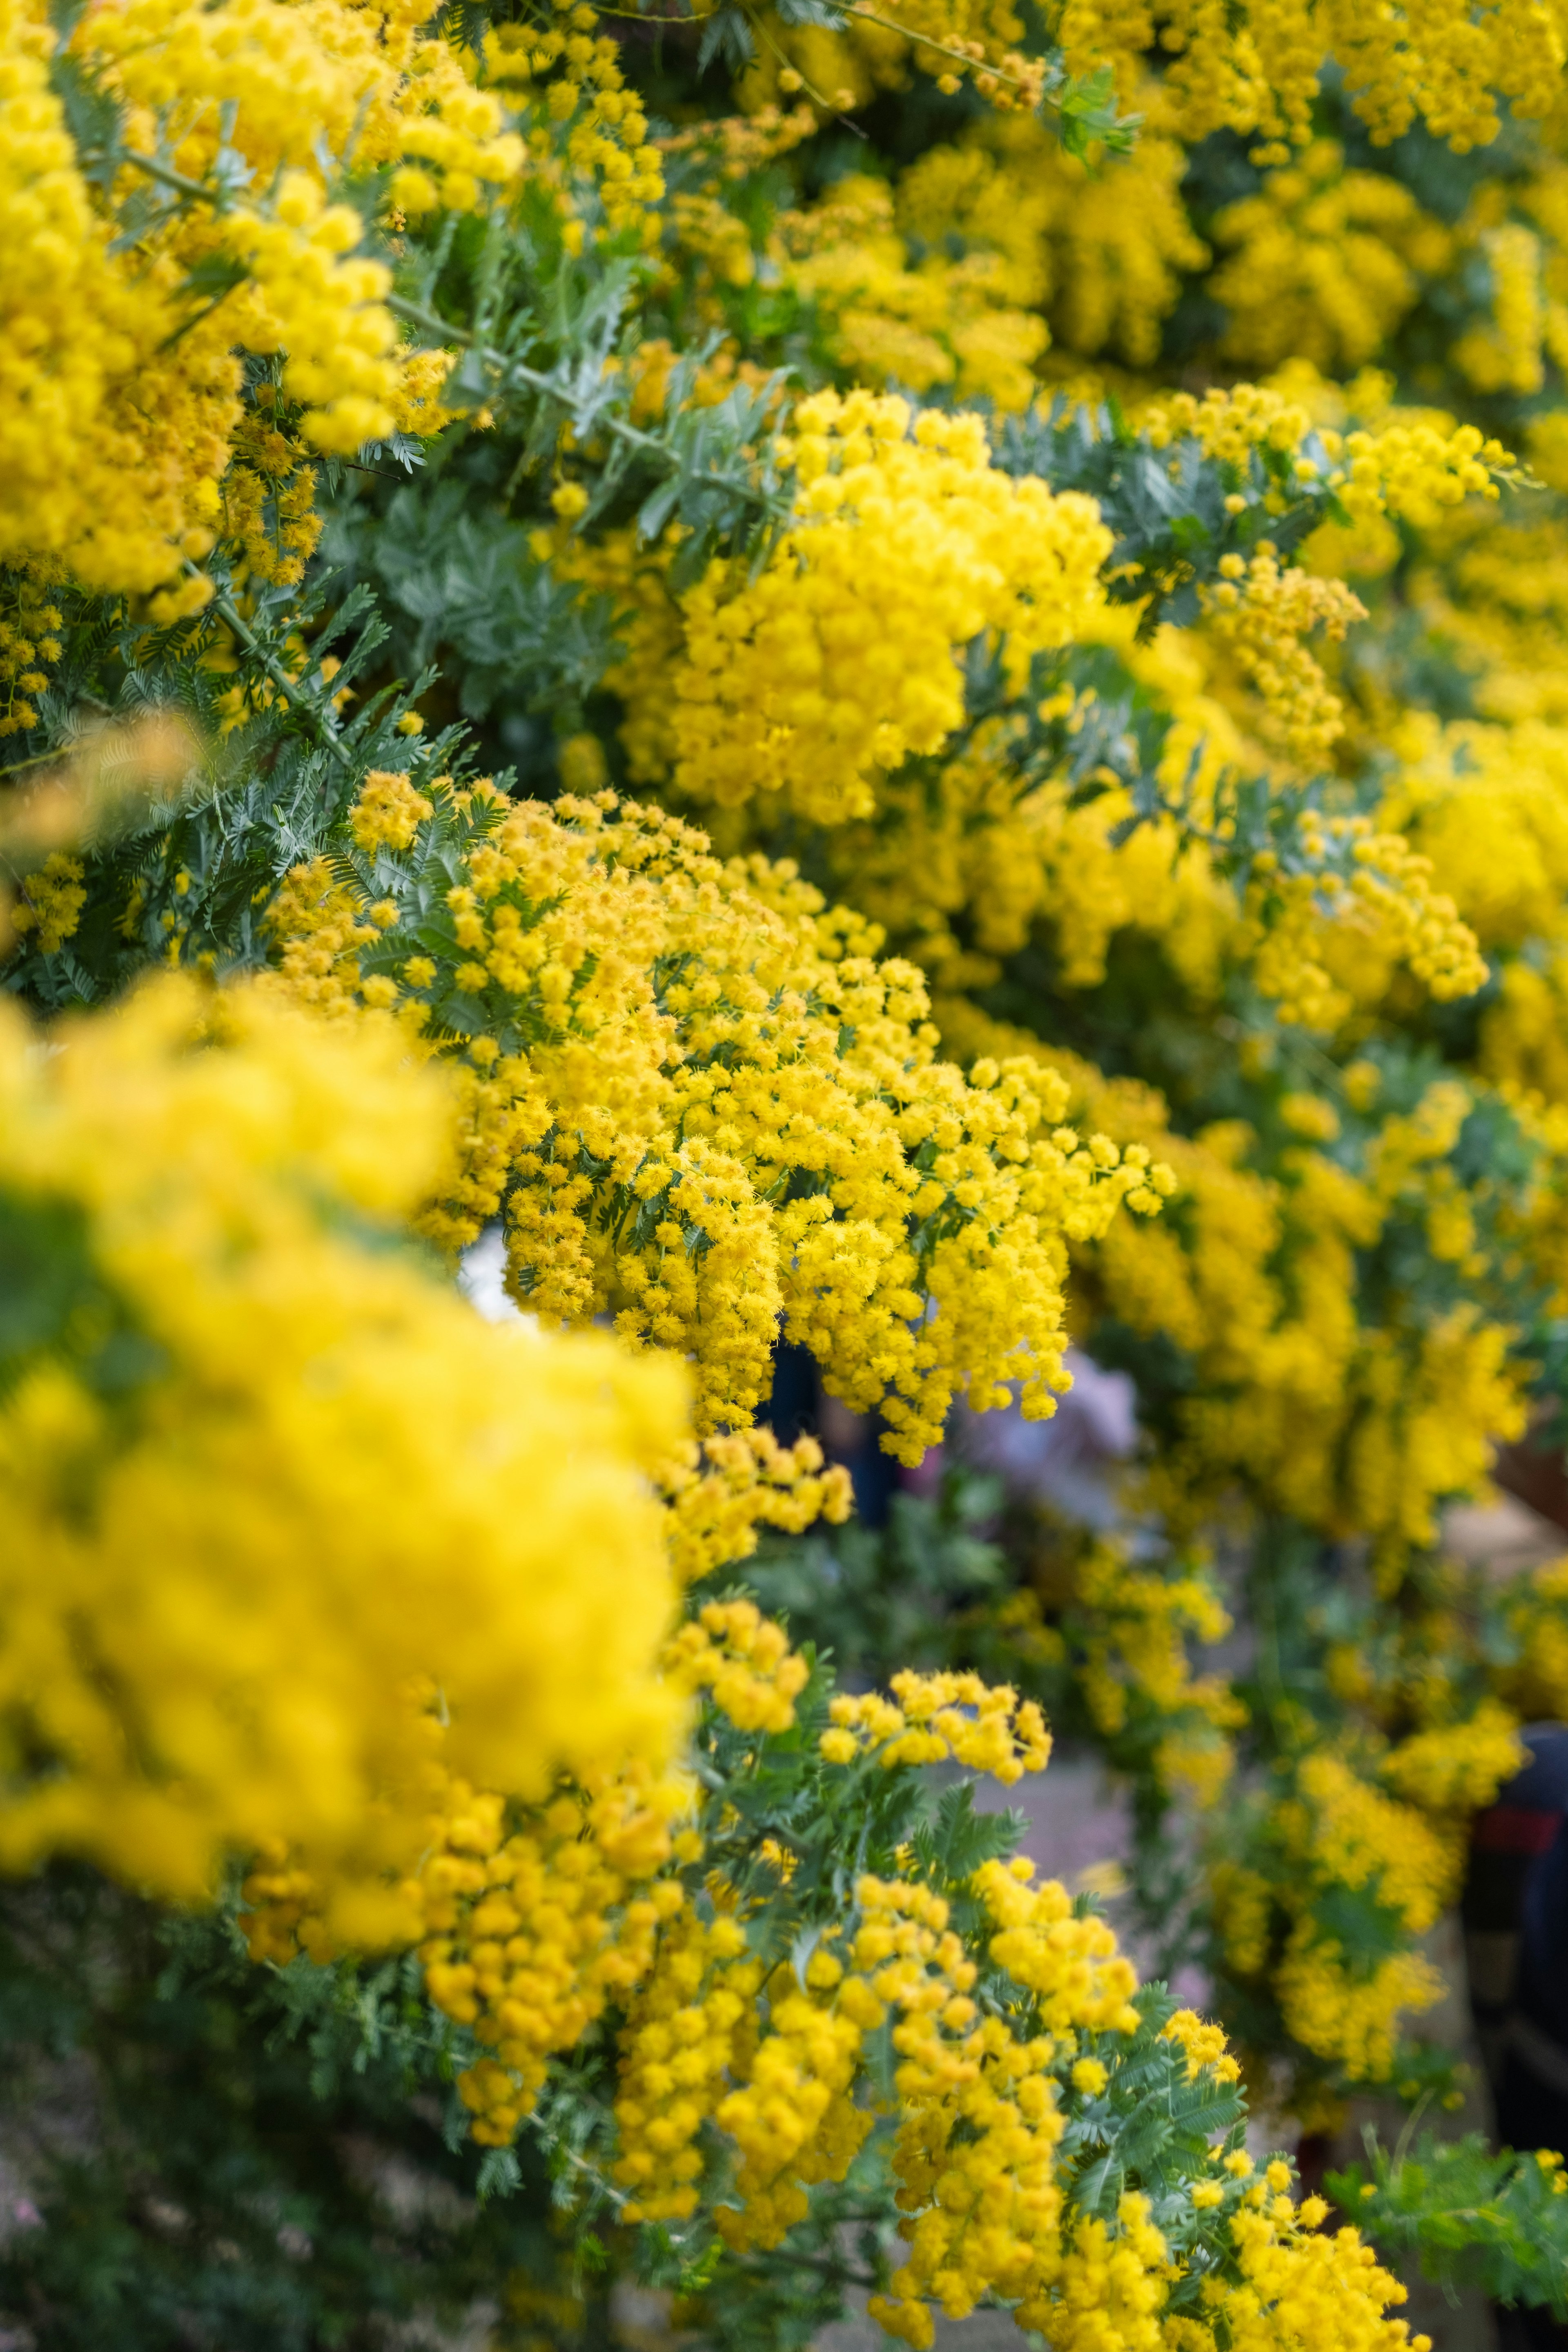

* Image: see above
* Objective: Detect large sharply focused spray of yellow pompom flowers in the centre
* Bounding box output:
[270,771,1168,1461]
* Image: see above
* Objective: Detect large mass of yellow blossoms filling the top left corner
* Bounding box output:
[0,0,663,592]
